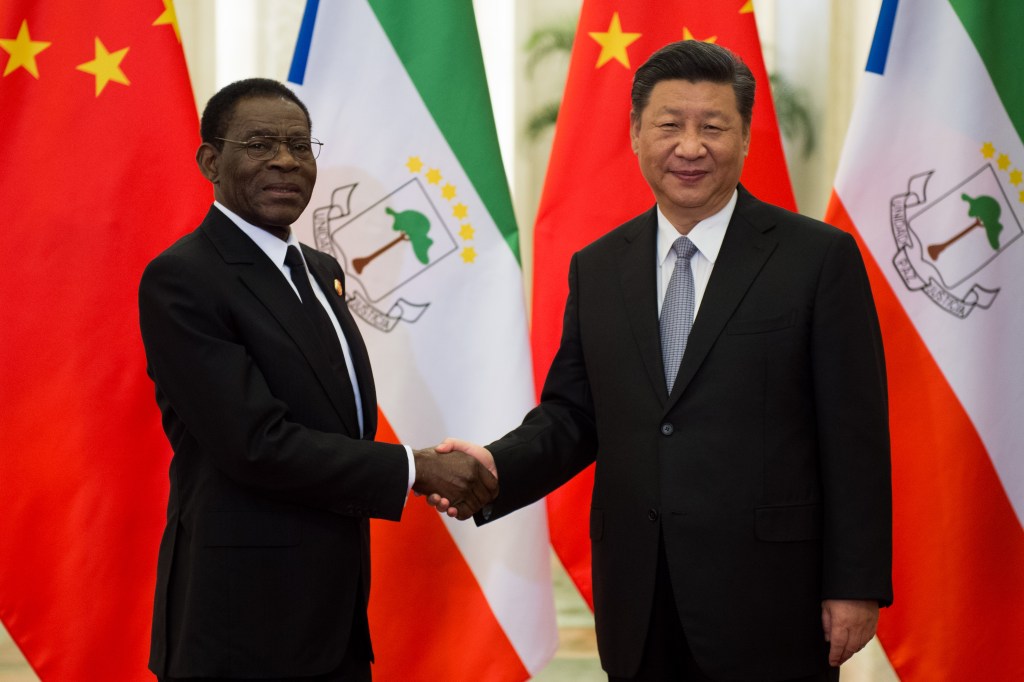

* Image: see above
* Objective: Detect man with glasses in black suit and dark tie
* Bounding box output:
[139,79,497,681]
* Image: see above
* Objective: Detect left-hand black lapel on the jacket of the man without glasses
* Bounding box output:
[621,208,668,402]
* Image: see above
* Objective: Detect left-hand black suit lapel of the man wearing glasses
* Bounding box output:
[202,208,359,433]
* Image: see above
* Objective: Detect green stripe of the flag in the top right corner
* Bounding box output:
[949,0,1024,140]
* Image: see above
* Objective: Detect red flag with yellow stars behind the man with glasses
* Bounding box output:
[0,0,212,680]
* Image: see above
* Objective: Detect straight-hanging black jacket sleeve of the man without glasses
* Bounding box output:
[811,233,893,605]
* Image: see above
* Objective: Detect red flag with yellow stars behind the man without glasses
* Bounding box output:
[531,0,796,608]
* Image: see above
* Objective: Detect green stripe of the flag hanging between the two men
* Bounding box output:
[369,0,520,261]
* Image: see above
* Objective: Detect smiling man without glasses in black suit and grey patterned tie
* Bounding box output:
[430,41,892,681]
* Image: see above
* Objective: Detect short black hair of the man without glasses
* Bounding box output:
[630,40,756,130]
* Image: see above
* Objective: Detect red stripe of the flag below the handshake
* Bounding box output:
[370,412,529,682]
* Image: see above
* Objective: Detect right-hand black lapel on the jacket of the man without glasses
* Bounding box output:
[667,187,776,408]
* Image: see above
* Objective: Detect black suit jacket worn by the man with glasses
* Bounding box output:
[139,208,409,678]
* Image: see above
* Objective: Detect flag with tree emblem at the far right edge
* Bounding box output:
[826,0,1024,682]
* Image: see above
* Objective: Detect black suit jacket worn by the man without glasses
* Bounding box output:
[479,187,892,680]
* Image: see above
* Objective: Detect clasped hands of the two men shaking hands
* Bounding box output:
[413,438,498,521]
